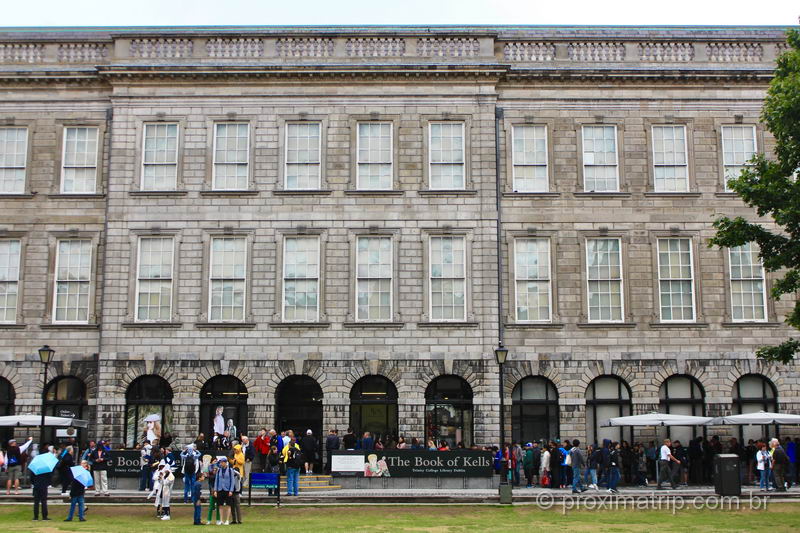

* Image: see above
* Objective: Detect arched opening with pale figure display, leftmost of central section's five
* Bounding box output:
[125,375,172,448]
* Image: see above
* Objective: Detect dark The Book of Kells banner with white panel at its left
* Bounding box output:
[331,450,494,477]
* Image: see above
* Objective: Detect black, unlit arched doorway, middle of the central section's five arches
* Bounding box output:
[275,376,323,443]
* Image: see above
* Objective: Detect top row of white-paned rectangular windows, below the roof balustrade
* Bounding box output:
[0,122,757,194]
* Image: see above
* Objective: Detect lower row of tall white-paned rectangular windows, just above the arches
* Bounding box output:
[0,236,767,323]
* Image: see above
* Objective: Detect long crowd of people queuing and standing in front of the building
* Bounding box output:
[0,426,800,525]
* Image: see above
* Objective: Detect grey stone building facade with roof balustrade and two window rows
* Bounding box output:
[0,27,800,444]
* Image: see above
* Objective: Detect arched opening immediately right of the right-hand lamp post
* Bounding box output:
[511,376,559,443]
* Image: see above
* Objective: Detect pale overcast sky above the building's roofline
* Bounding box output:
[0,0,800,26]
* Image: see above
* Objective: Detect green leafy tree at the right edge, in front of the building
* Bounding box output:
[709,30,800,363]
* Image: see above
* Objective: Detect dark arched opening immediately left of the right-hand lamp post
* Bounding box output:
[425,376,472,448]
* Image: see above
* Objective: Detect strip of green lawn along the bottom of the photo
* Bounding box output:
[0,503,800,533]
